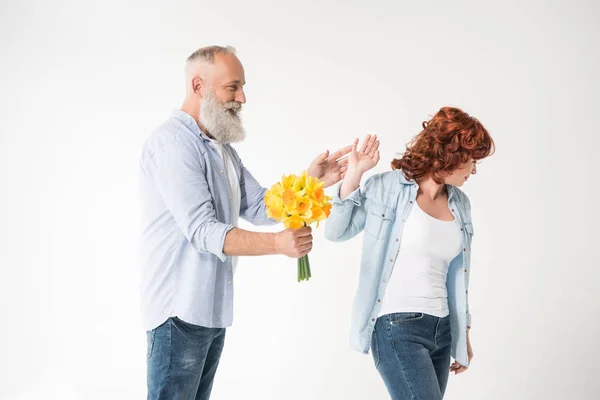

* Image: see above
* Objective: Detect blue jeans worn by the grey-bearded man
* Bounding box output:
[146,317,225,400]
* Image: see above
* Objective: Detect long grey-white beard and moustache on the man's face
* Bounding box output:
[200,89,246,144]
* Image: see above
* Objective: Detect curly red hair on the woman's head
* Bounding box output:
[392,107,495,184]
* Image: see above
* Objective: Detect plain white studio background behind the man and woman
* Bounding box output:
[0,0,600,400]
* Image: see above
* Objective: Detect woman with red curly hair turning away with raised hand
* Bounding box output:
[325,107,494,400]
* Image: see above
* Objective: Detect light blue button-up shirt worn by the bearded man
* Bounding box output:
[140,110,276,330]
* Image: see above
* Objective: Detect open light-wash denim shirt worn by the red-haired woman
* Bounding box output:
[325,170,473,366]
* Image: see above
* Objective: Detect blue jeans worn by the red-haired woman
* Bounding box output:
[371,312,452,400]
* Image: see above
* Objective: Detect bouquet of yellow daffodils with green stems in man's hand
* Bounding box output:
[265,171,331,282]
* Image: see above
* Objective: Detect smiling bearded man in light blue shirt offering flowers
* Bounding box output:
[140,46,351,399]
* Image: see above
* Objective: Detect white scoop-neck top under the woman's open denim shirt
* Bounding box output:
[379,202,462,318]
